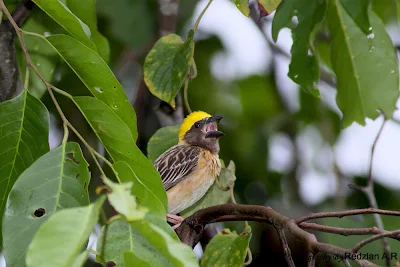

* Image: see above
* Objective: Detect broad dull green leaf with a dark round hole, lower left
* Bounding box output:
[3,143,89,267]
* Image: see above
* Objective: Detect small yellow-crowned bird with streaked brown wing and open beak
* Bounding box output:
[154,111,224,214]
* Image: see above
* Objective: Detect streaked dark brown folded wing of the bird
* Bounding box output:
[154,145,201,190]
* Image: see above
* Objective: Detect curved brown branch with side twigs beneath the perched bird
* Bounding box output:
[176,204,394,266]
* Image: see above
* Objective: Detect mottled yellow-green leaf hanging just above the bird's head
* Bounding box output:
[144,30,194,108]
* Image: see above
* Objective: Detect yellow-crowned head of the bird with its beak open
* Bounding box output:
[179,111,224,154]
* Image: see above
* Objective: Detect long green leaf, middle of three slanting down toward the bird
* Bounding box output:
[42,34,137,140]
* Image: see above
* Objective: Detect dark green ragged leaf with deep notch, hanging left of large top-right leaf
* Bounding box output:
[272,0,326,97]
